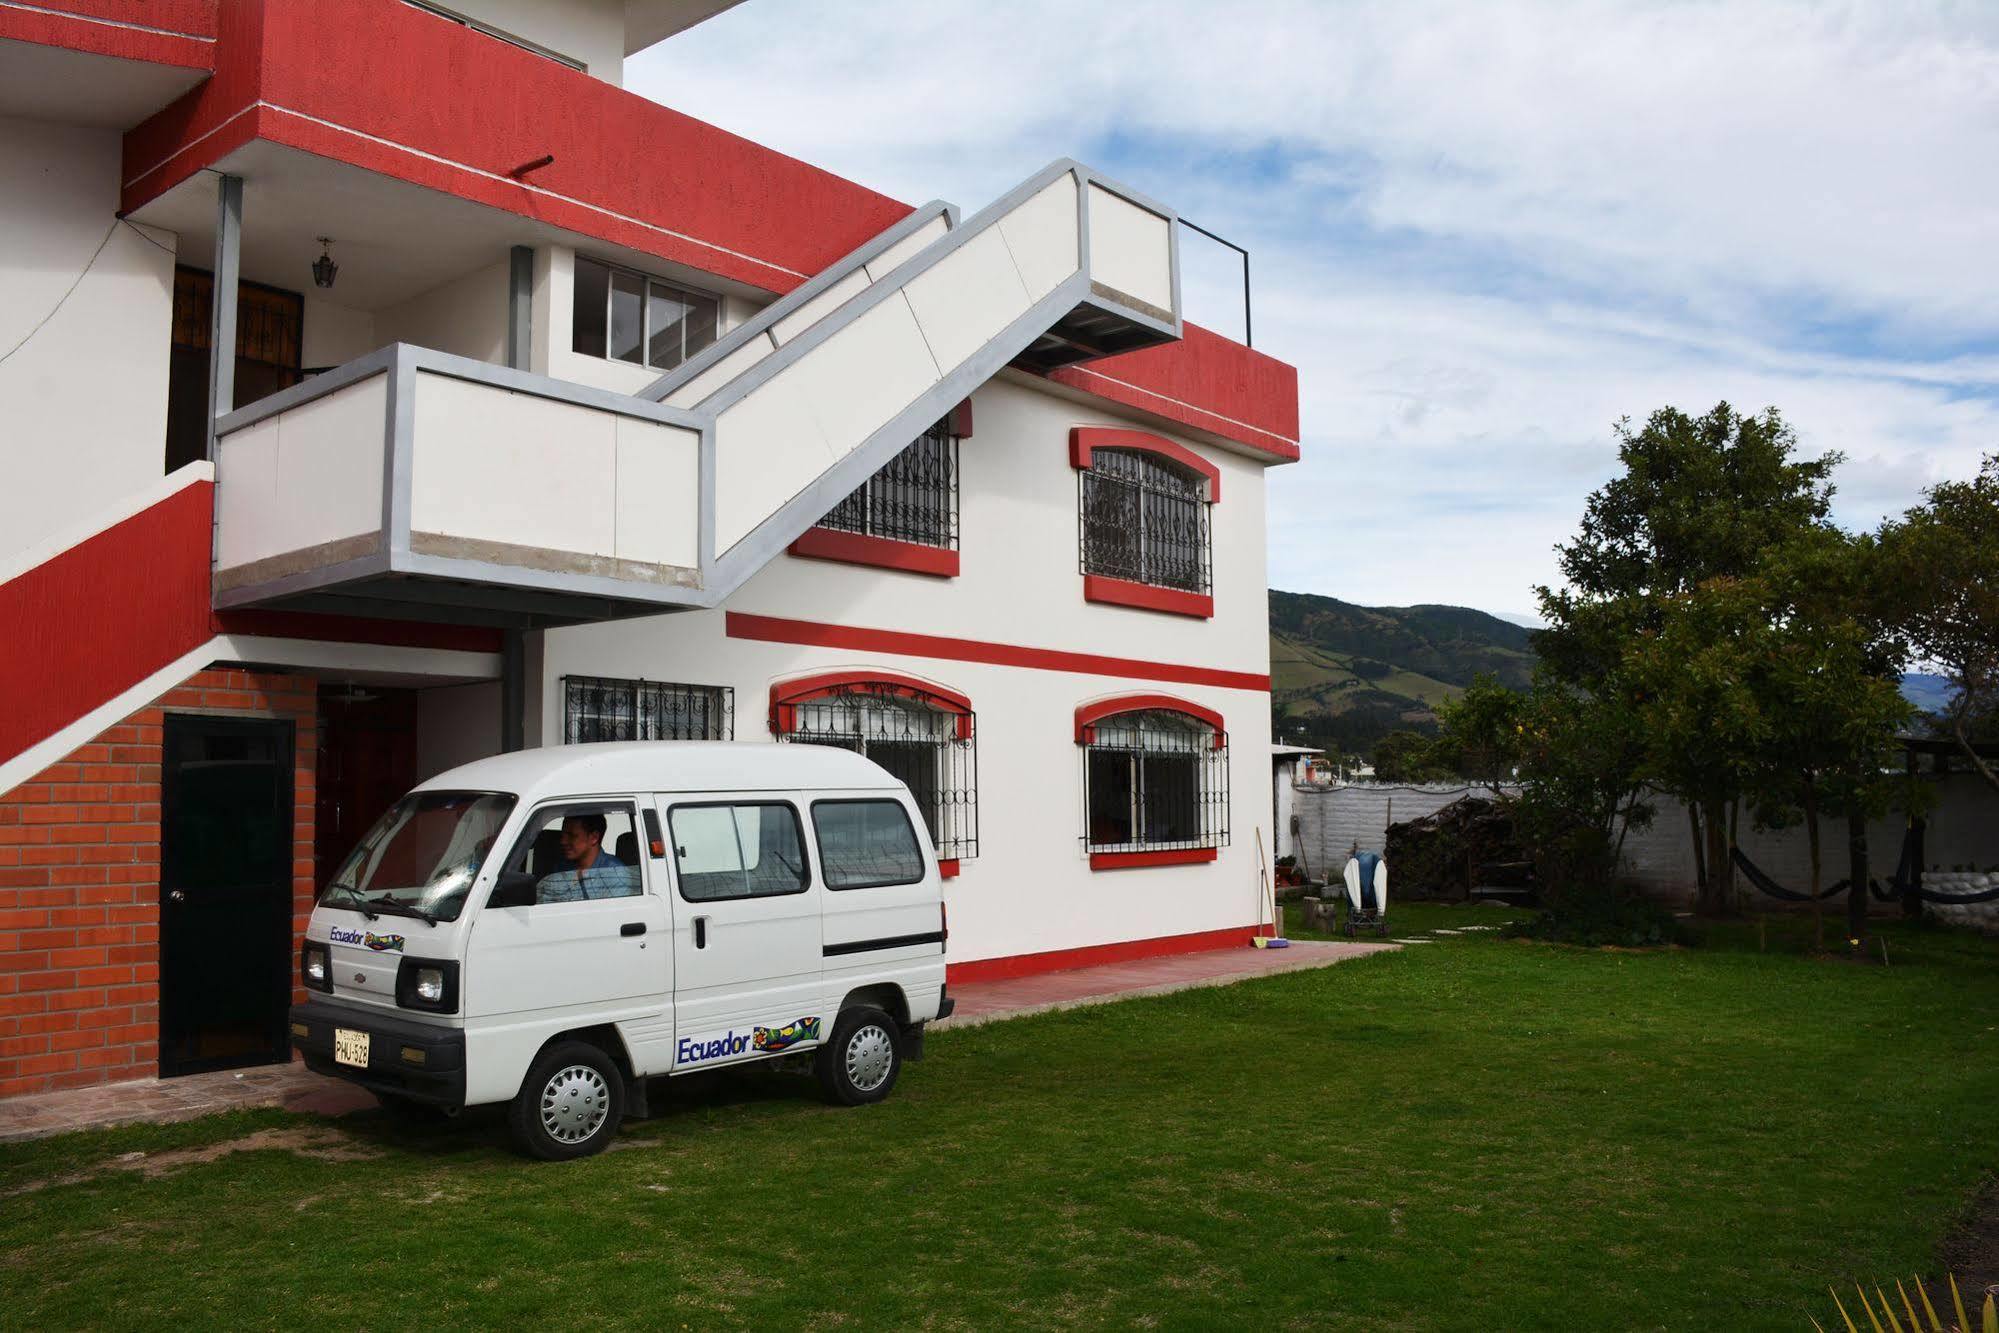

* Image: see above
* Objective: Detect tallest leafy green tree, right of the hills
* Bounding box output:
[1535,402,1839,911]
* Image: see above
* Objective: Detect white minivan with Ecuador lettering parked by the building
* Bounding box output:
[292,741,952,1159]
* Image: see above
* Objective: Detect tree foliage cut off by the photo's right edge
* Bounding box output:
[1881,454,1999,789]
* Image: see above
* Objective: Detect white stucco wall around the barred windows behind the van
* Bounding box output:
[530,382,1271,961]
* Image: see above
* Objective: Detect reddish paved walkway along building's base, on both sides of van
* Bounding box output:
[0,939,1397,1143]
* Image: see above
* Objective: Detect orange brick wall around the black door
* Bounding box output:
[0,669,318,1097]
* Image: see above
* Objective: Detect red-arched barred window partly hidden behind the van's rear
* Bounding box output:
[772,681,980,861]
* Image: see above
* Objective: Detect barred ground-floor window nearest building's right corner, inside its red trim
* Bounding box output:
[1083,709,1229,851]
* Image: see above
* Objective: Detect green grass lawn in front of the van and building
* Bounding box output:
[0,907,1999,1329]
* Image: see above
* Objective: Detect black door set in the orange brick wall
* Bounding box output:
[160,713,294,1077]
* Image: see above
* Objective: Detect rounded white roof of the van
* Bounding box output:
[416,741,898,799]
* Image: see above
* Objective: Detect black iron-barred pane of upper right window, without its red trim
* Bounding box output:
[1075,450,1213,594]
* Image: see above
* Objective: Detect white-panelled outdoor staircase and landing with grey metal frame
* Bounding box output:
[216,162,1181,628]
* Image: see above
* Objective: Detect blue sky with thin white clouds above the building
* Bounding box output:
[626,0,1999,627]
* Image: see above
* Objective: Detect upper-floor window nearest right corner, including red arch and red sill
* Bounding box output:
[1069,426,1221,616]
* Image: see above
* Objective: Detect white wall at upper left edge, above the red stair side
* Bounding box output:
[0,118,176,560]
